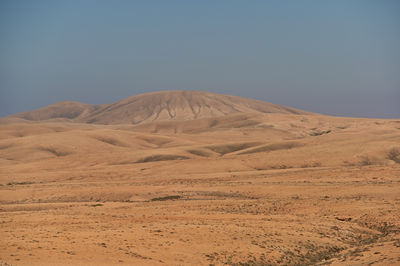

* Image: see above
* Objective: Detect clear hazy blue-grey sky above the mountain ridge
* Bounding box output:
[0,0,400,118]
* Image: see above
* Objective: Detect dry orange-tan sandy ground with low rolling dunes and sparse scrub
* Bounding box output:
[0,114,400,265]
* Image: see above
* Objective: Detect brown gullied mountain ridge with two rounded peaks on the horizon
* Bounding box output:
[11,91,310,124]
